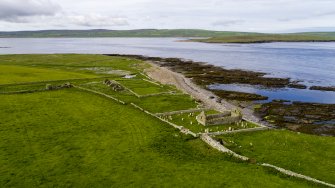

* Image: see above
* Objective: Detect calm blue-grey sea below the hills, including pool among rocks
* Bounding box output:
[0,38,335,103]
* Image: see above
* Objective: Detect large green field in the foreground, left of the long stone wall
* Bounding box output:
[0,88,316,188]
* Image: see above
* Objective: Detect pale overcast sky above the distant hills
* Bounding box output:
[0,0,335,32]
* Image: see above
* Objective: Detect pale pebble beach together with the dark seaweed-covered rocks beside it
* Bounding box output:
[105,54,335,136]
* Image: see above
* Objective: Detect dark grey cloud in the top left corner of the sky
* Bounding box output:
[0,0,61,22]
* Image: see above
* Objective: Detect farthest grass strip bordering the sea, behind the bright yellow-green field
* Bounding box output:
[0,54,149,76]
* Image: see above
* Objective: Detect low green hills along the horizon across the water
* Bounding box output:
[0,29,335,43]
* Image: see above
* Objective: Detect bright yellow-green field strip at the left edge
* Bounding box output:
[0,64,94,84]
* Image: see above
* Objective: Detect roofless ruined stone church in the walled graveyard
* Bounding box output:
[196,109,242,126]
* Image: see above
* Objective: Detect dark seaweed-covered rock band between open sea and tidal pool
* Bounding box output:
[104,54,335,94]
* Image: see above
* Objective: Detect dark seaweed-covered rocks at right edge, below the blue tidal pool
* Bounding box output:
[255,101,335,136]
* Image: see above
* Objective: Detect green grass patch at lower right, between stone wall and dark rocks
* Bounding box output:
[218,130,335,184]
